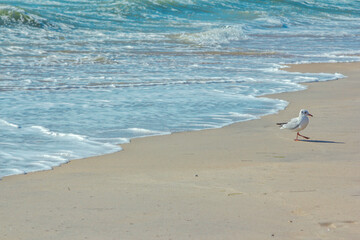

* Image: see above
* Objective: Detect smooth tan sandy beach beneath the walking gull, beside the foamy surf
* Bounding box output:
[0,63,360,240]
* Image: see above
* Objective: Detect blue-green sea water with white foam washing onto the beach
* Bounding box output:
[0,0,360,177]
